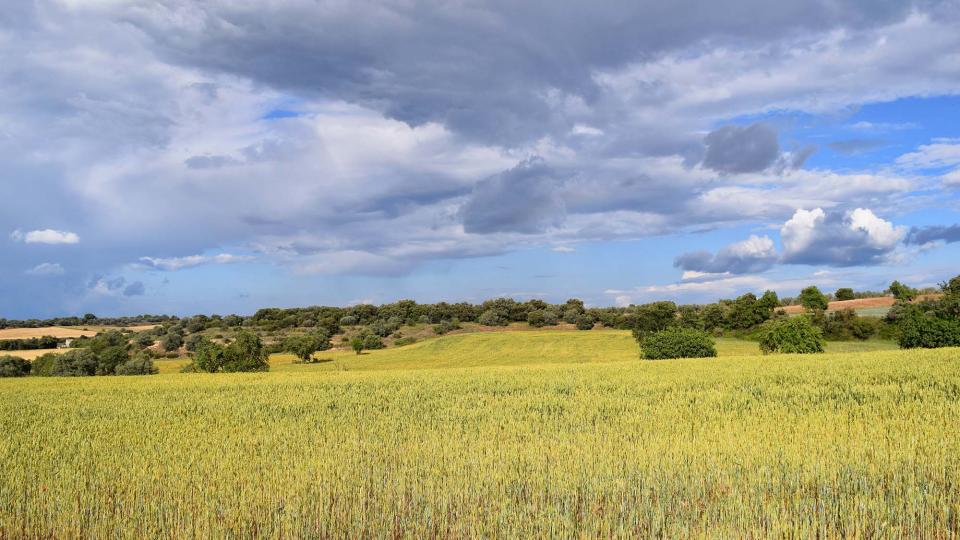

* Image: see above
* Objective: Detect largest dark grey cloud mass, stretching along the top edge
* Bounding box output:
[121,0,928,144]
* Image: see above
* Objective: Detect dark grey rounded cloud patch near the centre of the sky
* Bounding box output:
[460,158,566,234]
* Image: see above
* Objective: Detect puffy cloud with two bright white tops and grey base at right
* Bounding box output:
[780,208,907,266]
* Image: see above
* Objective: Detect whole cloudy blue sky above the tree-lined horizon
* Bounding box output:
[0,0,960,318]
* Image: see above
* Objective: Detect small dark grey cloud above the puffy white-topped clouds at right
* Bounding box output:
[703,123,780,173]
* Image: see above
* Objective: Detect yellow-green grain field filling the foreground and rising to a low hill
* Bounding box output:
[0,332,960,538]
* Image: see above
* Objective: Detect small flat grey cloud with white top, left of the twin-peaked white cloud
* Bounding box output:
[673,235,778,279]
